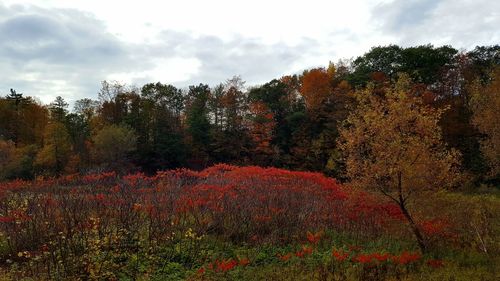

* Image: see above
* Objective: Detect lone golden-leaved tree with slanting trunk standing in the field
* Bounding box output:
[338,76,458,252]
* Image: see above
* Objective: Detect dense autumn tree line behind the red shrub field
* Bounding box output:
[0,45,500,183]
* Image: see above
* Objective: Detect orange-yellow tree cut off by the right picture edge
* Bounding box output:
[470,67,500,177]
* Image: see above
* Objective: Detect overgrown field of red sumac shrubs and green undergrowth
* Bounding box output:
[0,165,500,280]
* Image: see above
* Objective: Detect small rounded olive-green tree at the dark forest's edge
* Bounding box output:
[92,125,137,170]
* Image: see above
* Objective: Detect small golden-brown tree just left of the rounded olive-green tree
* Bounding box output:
[35,122,72,175]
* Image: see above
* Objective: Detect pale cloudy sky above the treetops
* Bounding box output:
[0,0,500,103]
